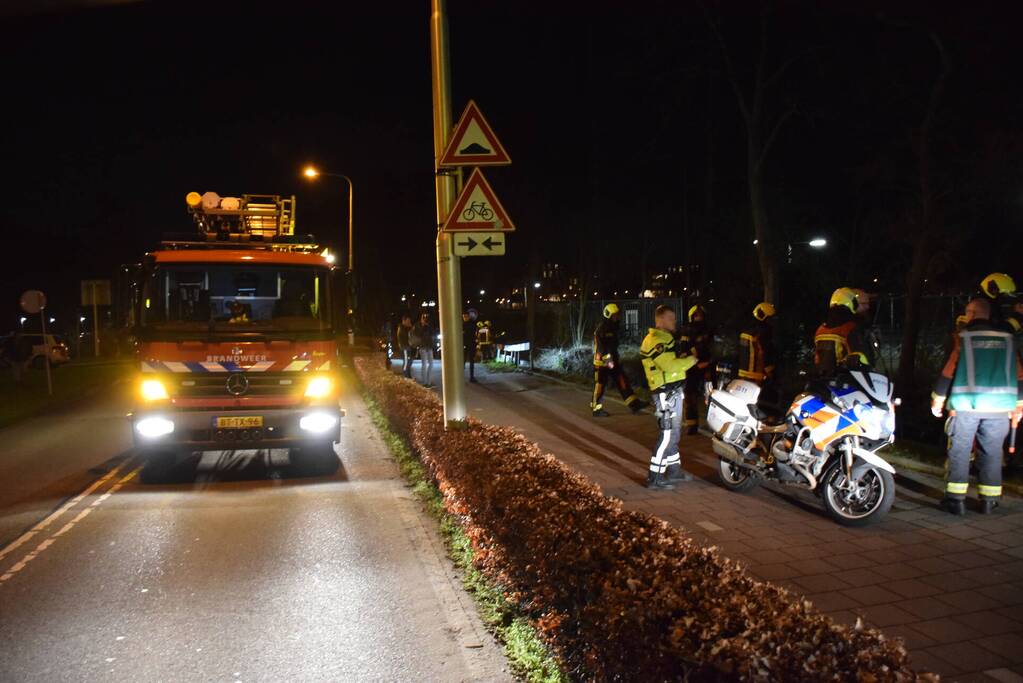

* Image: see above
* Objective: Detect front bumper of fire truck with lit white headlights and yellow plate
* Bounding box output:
[128,405,345,451]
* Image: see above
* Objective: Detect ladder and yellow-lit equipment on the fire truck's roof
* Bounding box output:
[163,192,318,252]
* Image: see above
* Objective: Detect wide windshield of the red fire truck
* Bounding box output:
[140,263,331,336]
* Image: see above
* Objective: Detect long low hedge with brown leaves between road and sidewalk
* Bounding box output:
[356,359,931,681]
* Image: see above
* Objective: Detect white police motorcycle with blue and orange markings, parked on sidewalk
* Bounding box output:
[707,366,899,527]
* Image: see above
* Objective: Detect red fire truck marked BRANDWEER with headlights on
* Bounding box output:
[129,192,344,481]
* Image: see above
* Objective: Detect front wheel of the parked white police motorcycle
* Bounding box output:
[820,460,895,527]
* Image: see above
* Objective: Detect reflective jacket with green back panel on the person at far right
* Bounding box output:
[934,320,1023,415]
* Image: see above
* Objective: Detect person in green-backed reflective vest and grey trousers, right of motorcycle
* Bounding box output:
[931,298,1023,514]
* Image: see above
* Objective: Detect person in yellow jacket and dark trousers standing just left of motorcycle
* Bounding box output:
[639,306,697,489]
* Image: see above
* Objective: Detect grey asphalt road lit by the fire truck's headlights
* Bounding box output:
[0,382,509,681]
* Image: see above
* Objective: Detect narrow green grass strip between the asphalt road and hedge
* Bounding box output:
[352,373,569,683]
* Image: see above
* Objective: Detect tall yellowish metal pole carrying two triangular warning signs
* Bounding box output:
[430,0,466,428]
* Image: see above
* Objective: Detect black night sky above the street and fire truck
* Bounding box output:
[0,0,1023,331]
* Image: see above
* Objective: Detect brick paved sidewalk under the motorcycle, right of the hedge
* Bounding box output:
[403,359,1023,681]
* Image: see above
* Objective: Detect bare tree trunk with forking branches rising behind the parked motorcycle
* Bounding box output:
[707,10,795,303]
